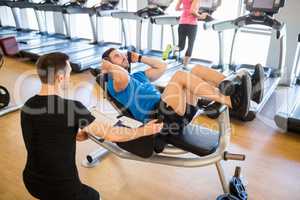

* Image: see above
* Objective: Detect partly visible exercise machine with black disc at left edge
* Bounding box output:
[0,51,22,116]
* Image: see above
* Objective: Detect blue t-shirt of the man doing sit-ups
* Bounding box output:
[107,71,161,122]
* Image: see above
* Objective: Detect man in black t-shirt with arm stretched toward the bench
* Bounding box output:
[21,53,162,200]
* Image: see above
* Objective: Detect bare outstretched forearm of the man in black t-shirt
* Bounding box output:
[83,120,163,142]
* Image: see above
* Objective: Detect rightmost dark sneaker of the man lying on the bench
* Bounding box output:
[251,64,265,104]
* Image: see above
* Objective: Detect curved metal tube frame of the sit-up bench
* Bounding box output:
[83,106,245,193]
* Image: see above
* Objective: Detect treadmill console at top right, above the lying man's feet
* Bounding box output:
[245,0,285,15]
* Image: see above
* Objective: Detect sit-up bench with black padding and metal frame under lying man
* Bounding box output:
[83,74,245,193]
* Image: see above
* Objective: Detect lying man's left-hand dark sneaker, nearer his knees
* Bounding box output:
[230,70,252,119]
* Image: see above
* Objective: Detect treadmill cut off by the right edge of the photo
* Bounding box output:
[274,34,300,133]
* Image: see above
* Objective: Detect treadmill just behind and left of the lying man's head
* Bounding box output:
[22,0,119,72]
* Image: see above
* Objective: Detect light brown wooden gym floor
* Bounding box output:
[0,59,300,200]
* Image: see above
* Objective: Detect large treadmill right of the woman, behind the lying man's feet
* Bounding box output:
[206,0,286,121]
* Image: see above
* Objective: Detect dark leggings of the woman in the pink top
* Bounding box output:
[178,24,198,57]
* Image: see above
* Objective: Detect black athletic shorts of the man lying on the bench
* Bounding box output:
[151,100,197,135]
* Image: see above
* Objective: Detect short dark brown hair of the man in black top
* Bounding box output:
[36,52,69,84]
